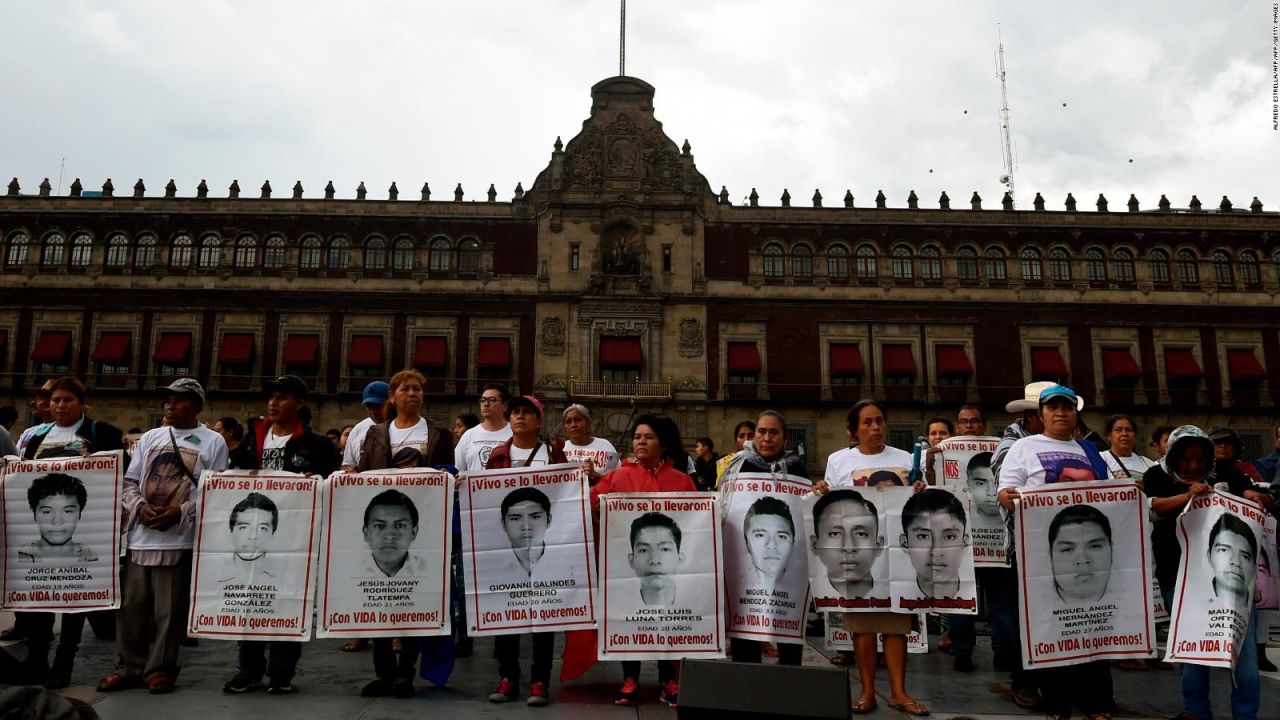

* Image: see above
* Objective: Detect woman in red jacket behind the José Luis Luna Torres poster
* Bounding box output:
[591,415,698,707]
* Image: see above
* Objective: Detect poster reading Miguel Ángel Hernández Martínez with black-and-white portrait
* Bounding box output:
[1015,480,1156,669]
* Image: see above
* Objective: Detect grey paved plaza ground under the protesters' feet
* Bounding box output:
[10,614,1280,720]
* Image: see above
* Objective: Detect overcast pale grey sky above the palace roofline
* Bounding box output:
[0,0,1280,210]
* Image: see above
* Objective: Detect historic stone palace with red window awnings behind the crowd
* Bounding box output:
[0,77,1280,465]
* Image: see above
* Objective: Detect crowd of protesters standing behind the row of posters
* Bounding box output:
[0,370,1280,720]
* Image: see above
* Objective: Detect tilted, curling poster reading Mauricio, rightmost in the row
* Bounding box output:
[1165,491,1265,667]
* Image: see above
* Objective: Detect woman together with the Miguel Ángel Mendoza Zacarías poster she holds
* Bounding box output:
[719,410,812,665]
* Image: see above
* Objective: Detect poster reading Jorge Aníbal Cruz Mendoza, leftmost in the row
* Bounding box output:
[0,451,124,612]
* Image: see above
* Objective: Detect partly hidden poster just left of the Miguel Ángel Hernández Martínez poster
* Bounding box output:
[934,436,1006,568]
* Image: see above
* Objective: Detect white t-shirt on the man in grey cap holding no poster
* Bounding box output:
[124,425,227,550]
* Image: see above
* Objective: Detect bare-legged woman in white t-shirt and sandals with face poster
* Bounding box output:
[809,400,929,715]
